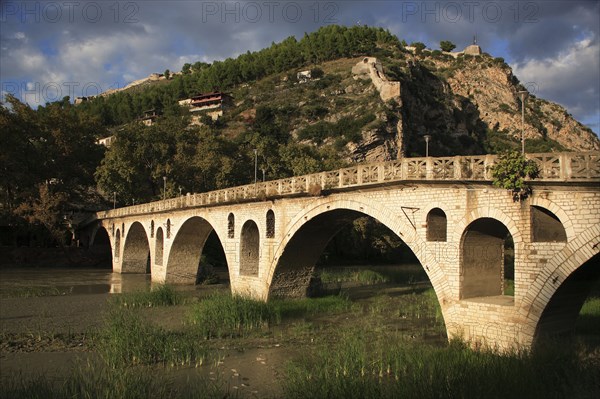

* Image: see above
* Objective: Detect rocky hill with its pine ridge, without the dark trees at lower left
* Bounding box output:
[85,26,600,162]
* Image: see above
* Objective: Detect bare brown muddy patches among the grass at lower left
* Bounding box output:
[0,294,298,398]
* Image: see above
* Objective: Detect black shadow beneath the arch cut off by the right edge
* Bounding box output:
[534,253,600,343]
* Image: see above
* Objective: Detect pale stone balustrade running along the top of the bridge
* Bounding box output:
[98,151,600,218]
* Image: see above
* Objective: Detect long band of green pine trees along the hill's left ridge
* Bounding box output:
[77,25,404,126]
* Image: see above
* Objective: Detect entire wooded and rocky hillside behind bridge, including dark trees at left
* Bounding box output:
[0,26,600,247]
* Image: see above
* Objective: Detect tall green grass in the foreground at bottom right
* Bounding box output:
[284,330,600,398]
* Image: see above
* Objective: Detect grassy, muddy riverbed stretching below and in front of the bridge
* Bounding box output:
[0,270,600,398]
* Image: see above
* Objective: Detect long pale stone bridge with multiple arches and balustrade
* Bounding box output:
[82,152,600,348]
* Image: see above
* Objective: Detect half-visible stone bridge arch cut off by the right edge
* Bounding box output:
[523,225,600,339]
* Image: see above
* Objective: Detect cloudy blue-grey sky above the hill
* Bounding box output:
[0,0,600,134]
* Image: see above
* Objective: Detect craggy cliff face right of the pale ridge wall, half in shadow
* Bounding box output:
[390,51,600,155]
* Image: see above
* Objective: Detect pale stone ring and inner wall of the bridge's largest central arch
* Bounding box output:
[266,198,449,303]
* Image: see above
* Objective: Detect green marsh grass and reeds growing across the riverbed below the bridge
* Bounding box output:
[0,276,600,399]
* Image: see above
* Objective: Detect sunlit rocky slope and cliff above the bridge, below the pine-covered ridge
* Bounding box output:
[203,47,600,162]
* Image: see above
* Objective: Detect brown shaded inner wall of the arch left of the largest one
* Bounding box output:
[165,216,229,284]
